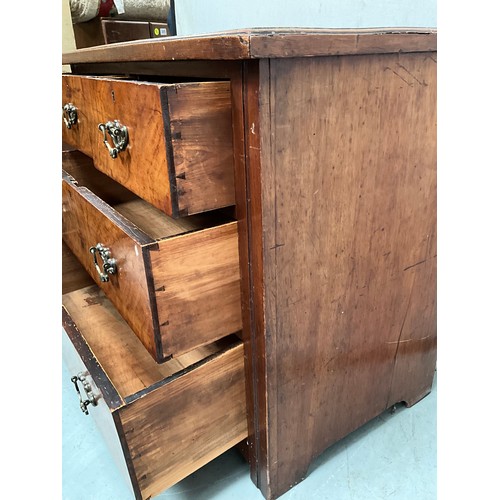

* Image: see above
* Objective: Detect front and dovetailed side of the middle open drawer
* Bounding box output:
[62,170,242,362]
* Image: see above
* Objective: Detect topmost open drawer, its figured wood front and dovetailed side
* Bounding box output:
[64,76,235,217]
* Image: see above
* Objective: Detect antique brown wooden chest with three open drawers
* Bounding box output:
[63,30,436,499]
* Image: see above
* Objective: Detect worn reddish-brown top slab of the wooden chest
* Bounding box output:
[62,28,436,64]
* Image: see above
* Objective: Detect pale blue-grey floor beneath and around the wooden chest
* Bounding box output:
[62,366,437,500]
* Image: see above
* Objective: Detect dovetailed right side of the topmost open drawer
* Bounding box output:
[163,82,235,215]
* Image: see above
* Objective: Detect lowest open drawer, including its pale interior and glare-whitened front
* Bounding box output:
[62,285,247,499]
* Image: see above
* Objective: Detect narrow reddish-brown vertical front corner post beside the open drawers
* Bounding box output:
[235,61,271,496]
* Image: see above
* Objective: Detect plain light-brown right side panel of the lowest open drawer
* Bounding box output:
[120,344,247,498]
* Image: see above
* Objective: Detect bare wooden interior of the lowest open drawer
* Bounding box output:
[62,285,238,399]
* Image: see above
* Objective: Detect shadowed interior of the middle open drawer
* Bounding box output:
[63,152,234,240]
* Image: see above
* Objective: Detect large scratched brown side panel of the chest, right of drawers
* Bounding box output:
[244,53,436,498]
